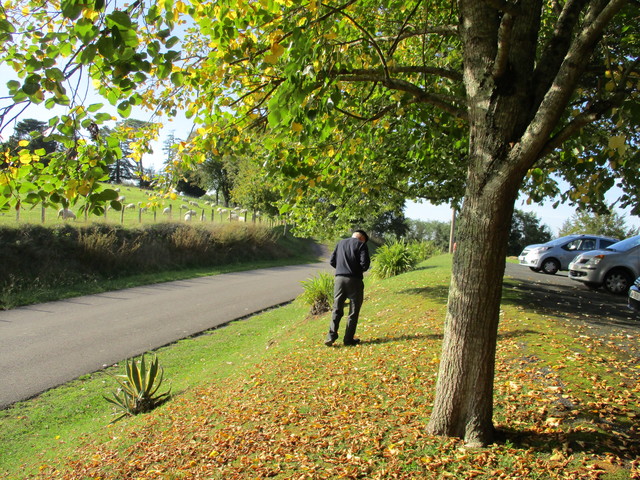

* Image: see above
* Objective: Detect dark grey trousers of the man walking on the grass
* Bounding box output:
[329,275,364,344]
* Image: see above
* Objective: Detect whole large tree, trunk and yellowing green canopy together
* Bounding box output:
[0,0,640,445]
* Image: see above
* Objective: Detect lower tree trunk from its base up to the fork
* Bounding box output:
[428,174,514,445]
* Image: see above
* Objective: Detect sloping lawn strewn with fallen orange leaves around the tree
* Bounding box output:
[0,255,640,480]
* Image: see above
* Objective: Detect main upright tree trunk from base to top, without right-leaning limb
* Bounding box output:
[428,0,540,445]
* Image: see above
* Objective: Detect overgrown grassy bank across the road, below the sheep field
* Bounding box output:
[0,222,317,309]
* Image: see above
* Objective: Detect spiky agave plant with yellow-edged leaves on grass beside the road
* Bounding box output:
[103,354,171,423]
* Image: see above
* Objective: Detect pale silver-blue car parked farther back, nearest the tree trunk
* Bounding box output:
[518,235,618,275]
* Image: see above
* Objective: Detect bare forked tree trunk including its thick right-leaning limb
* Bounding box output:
[428,0,625,446]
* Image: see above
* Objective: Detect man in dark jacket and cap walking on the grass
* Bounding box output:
[324,230,371,347]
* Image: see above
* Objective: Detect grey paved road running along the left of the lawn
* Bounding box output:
[0,263,330,408]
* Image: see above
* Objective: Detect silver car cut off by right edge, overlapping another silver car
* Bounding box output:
[569,235,640,294]
